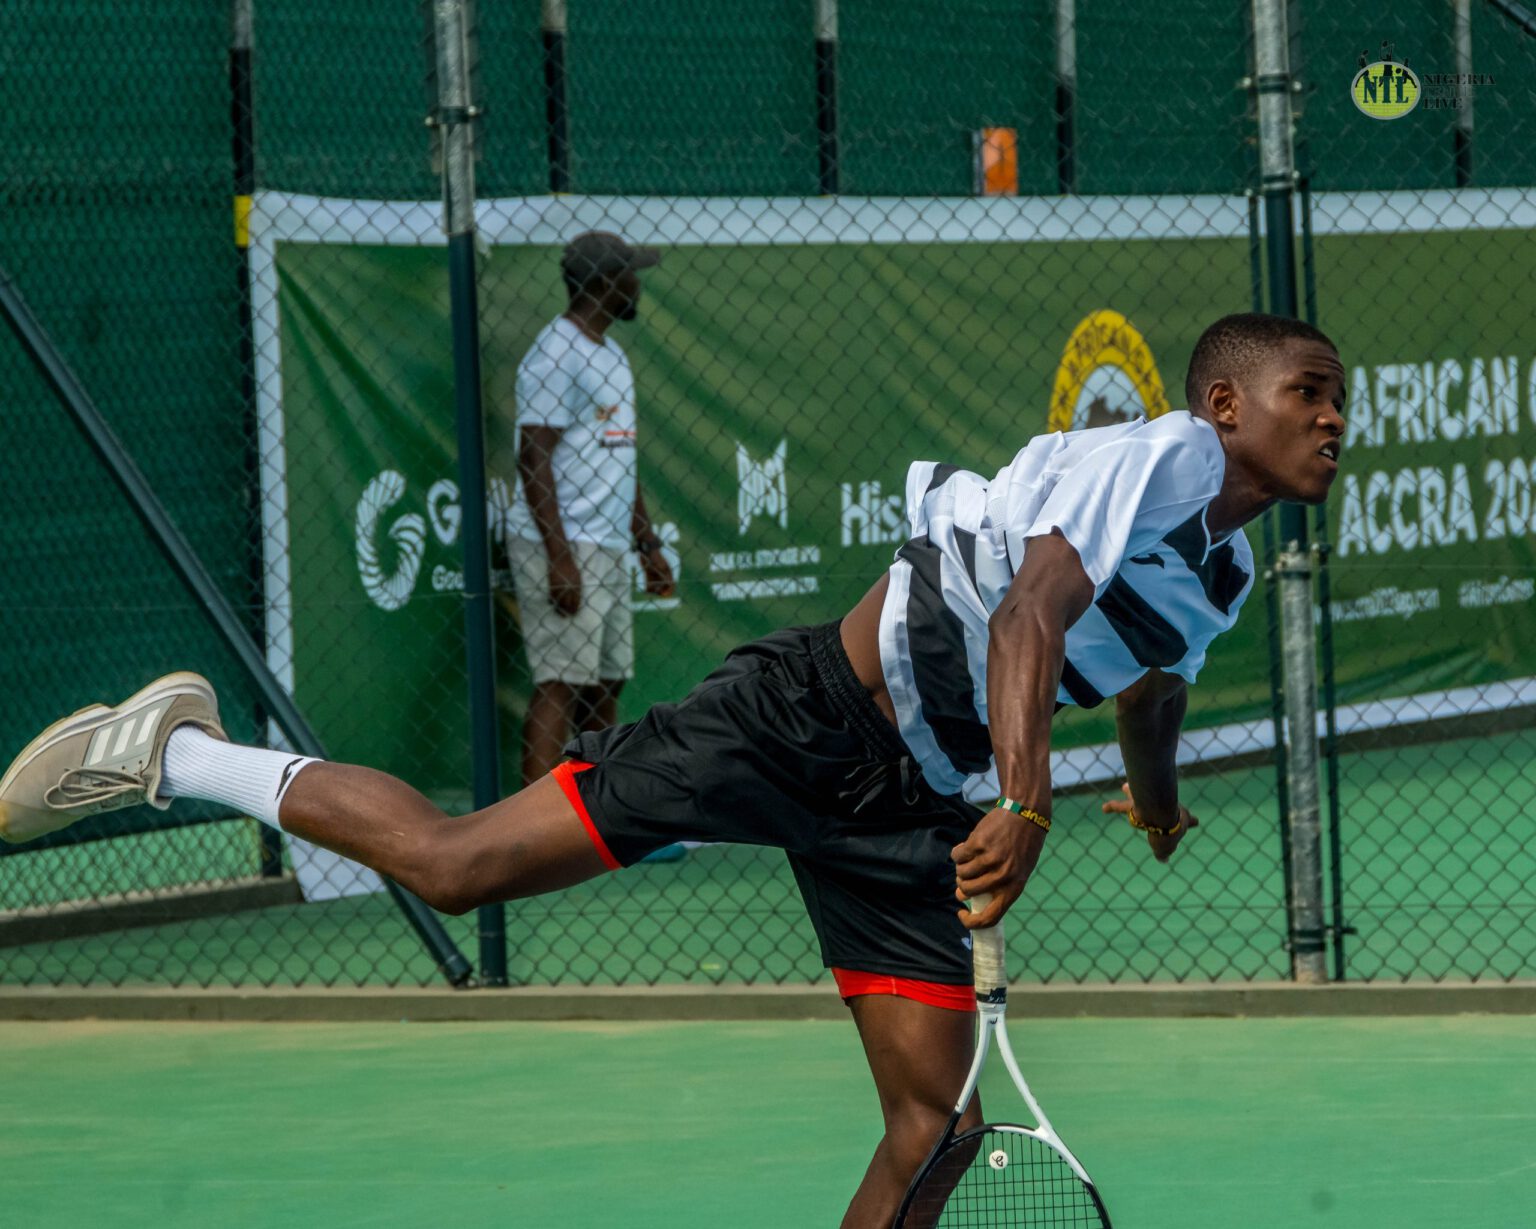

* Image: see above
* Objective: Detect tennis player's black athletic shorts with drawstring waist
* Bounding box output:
[558,624,980,989]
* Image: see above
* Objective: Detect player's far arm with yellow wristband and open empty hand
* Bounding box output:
[1103,670,1200,862]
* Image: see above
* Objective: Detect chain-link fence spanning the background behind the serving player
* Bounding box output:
[0,0,1536,986]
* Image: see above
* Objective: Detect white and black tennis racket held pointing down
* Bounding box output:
[895,894,1109,1229]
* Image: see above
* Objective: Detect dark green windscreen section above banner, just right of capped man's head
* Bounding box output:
[567,0,817,195]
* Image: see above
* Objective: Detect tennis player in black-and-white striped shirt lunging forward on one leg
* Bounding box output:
[0,315,1344,1226]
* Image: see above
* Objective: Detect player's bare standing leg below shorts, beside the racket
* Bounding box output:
[842,994,982,1229]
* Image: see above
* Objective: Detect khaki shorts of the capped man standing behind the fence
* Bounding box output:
[507,538,634,687]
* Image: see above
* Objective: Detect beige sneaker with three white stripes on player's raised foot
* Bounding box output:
[0,671,227,842]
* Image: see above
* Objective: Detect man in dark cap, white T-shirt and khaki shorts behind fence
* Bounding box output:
[507,230,673,782]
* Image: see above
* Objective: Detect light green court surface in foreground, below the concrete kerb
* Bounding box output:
[0,1013,1536,1229]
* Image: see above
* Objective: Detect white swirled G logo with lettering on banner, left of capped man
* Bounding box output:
[353,470,511,610]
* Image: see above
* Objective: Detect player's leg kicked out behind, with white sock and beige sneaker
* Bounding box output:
[0,673,611,913]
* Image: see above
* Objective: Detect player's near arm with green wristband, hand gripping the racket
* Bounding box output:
[951,533,1094,929]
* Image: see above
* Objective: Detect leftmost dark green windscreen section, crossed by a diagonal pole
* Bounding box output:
[0,0,260,754]
